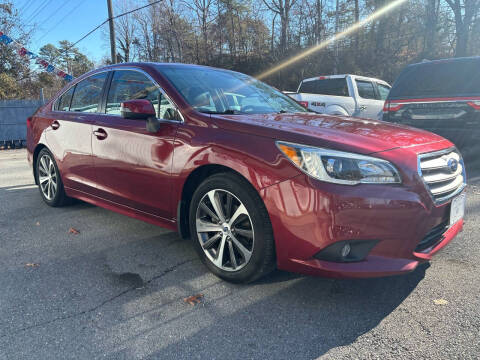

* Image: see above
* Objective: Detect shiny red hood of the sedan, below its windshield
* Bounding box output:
[211,113,445,154]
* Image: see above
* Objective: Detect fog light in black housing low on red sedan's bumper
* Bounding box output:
[314,240,378,262]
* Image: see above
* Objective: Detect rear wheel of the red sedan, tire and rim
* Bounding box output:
[36,148,70,207]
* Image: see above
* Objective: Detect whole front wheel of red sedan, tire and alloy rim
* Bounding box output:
[189,173,275,282]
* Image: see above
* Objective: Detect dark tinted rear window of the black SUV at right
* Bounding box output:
[389,58,480,98]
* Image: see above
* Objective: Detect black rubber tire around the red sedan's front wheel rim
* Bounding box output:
[189,173,272,282]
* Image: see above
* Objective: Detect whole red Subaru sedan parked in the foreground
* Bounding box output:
[27,63,466,282]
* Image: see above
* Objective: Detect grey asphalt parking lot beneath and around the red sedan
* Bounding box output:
[0,150,480,359]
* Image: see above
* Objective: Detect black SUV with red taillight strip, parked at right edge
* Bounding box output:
[383,56,480,160]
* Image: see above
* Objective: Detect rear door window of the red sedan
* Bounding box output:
[70,72,108,112]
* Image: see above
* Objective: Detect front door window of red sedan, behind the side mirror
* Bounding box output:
[105,70,160,116]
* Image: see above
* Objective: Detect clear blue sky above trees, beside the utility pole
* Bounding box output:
[12,0,111,63]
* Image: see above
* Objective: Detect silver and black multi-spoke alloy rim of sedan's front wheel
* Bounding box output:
[196,189,254,271]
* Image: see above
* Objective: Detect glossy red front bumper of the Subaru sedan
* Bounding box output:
[260,175,463,278]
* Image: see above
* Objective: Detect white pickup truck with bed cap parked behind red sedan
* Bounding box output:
[285,74,390,120]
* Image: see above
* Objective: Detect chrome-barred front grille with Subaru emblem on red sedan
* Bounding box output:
[418,149,466,203]
